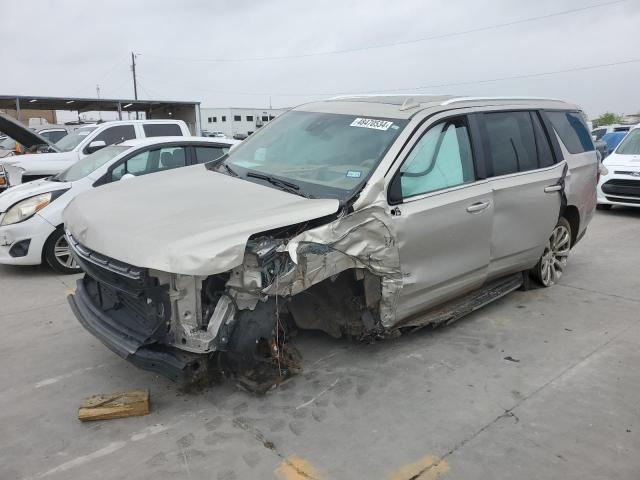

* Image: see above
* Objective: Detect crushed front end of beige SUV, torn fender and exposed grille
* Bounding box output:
[67,207,401,392]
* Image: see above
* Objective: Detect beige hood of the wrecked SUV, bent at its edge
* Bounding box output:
[63,165,339,275]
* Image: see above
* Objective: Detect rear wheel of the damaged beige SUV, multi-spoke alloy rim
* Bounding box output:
[531,217,572,287]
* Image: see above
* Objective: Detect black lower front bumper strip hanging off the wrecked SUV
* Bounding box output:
[67,280,206,383]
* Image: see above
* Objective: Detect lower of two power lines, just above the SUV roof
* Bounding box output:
[142,58,640,97]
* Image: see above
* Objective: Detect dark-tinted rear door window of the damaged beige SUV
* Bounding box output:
[483,112,538,177]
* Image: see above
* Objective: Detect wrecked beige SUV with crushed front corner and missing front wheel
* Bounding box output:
[64,96,598,391]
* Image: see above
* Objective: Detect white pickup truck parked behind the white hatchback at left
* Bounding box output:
[0,120,191,191]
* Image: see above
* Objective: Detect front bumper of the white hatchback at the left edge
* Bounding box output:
[0,214,55,265]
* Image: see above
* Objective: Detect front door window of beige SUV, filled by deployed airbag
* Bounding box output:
[400,117,475,198]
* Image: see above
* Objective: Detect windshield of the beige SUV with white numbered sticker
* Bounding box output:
[220,111,407,199]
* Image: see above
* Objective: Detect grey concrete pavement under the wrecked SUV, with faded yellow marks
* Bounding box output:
[0,209,640,480]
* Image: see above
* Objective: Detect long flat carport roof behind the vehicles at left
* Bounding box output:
[0,95,200,112]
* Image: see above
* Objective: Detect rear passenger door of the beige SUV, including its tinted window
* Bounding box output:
[476,111,566,280]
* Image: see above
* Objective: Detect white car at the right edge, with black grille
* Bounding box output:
[598,125,640,210]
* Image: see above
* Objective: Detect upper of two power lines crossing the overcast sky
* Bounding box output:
[145,0,629,63]
